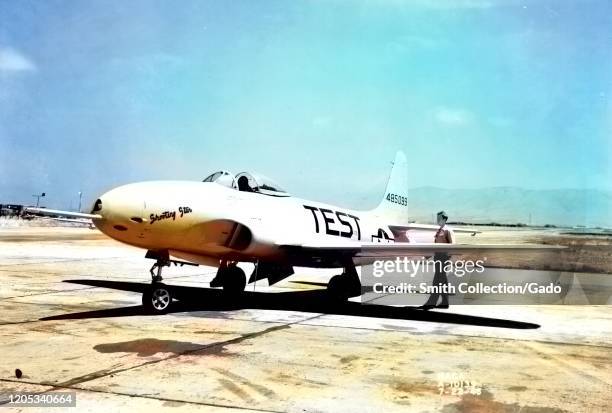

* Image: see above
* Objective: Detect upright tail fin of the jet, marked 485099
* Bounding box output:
[370,151,408,225]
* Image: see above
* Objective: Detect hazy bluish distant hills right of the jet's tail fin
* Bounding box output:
[408,187,612,228]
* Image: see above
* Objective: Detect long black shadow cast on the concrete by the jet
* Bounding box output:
[41,280,540,329]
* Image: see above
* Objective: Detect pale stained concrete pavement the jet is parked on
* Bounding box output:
[0,228,612,413]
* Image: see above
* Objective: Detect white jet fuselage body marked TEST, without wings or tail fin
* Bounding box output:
[94,181,432,265]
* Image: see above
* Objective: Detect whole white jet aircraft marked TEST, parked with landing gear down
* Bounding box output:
[28,152,552,313]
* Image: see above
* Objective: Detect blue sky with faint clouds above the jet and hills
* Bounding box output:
[0,0,612,208]
